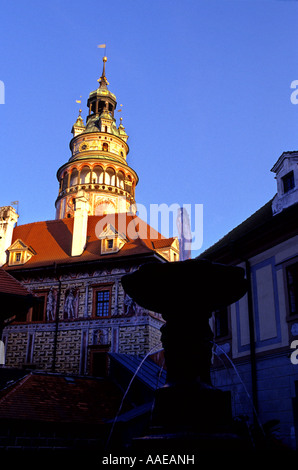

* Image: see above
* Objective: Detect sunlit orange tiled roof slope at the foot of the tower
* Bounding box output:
[5,214,174,270]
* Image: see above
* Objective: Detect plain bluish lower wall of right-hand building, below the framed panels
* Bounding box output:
[212,353,298,449]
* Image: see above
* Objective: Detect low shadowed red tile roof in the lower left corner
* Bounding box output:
[0,373,128,424]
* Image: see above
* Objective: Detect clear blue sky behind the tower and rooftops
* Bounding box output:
[0,0,298,255]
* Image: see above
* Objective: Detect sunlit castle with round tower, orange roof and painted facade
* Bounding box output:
[0,57,179,376]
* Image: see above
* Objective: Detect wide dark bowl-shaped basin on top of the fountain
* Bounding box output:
[121,259,247,319]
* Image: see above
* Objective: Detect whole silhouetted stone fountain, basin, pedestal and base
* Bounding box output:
[122,259,247,451]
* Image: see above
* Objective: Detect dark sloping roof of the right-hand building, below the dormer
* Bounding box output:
[198,200,298,263]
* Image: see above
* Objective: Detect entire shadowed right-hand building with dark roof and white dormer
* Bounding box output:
[199,151,298,449]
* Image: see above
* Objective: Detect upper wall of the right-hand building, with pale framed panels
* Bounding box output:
[231,236,298,358]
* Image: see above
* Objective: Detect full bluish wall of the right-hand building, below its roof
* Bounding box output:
[212,236,298,448]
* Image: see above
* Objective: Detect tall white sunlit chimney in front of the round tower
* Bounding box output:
[71,191,89,256]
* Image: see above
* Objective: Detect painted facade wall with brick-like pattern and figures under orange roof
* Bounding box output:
[3,268,162,374]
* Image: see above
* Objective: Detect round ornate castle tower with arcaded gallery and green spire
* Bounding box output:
[55,57,138,219]
